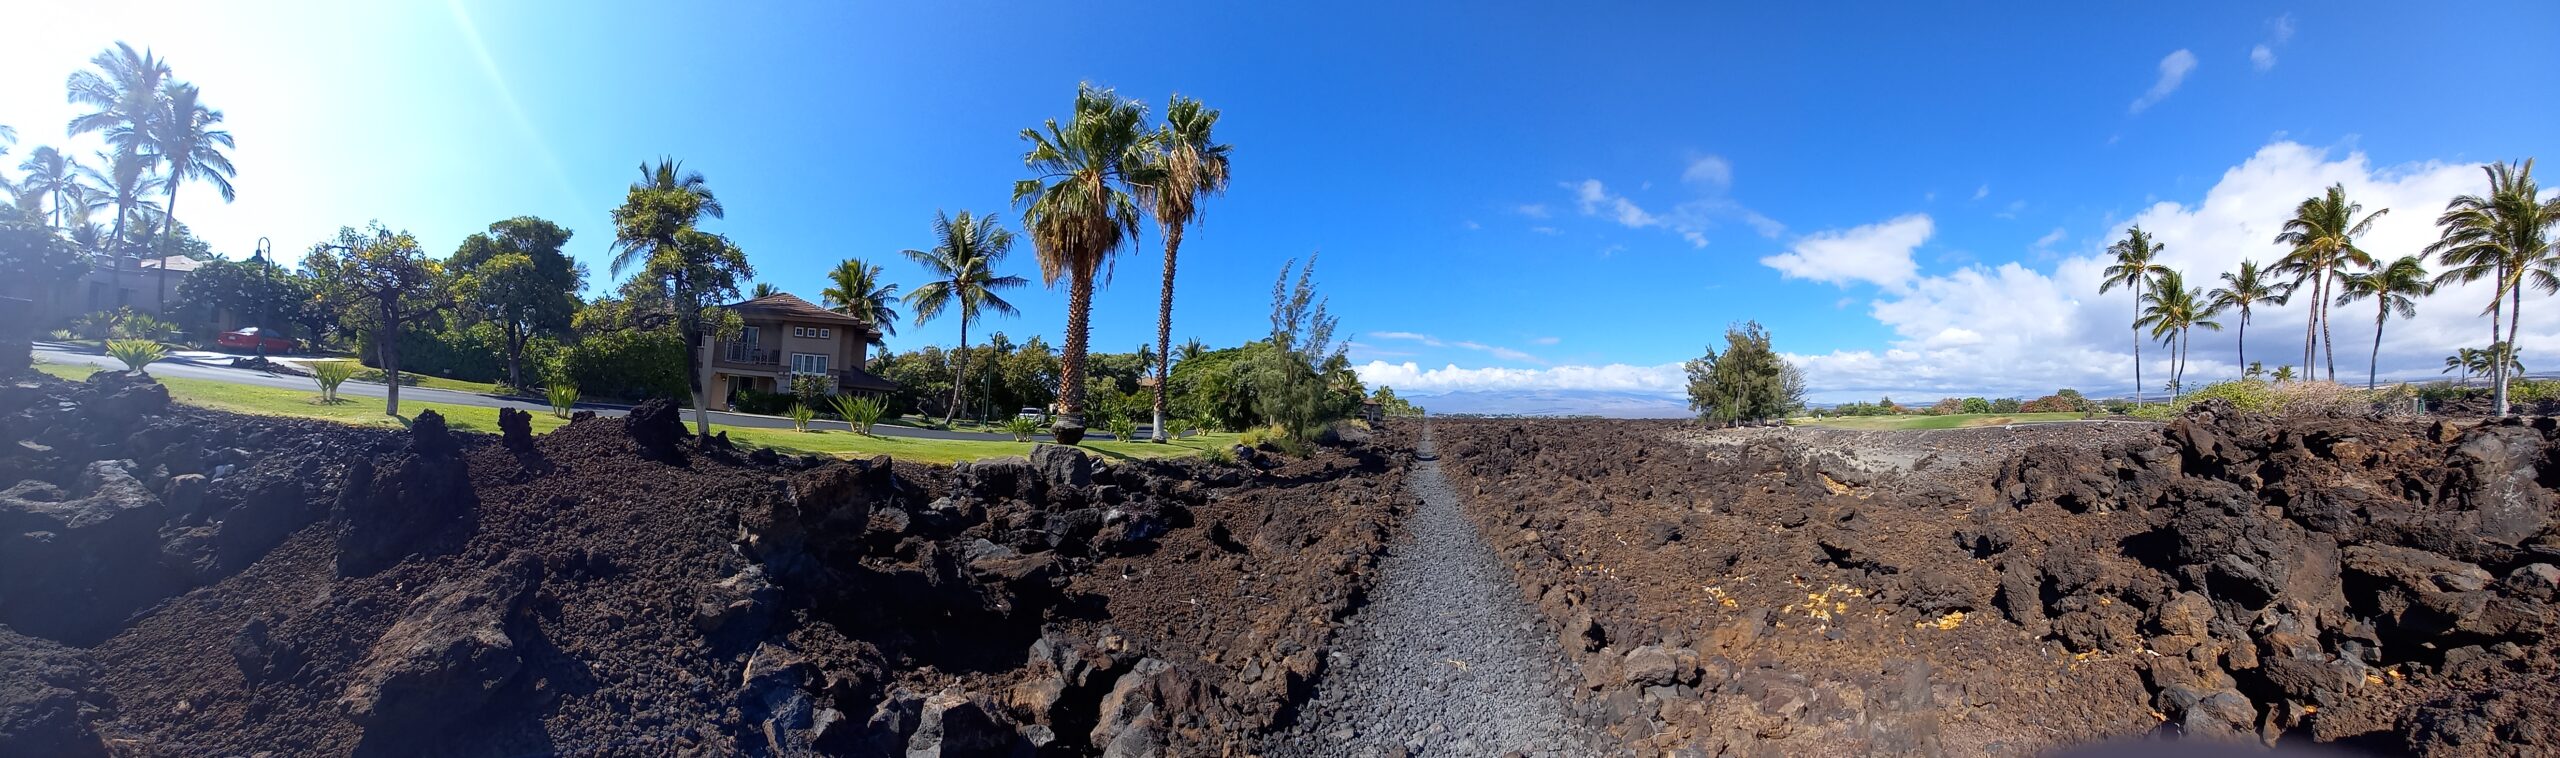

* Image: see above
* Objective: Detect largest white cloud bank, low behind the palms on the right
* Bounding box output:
[1779,141,2560,402]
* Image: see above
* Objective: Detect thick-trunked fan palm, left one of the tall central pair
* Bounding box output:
[1014,85,1155,446]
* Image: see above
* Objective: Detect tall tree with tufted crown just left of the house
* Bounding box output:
[612,159,755,438]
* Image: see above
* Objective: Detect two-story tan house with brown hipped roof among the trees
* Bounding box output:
[701,292,896,410]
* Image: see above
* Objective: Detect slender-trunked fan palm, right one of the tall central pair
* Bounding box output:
[1137,95,1231,443]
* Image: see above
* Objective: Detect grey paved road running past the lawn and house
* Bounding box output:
[36,343,1064,440]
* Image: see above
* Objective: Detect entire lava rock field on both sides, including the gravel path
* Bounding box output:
[0,363,2560,755]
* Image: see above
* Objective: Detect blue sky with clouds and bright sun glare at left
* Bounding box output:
[0,3,2560,412]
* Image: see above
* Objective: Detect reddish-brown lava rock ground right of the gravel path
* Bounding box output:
[1439,407,2560,755]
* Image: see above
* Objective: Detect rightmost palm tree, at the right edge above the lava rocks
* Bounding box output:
[2427,159,2560,415]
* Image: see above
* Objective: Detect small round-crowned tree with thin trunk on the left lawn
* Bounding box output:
[305,223,445,415]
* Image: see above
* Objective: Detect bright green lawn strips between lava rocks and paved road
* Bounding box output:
[36,364,1239,464]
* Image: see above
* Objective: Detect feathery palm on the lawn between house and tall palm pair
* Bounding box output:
[904,210,1029,425]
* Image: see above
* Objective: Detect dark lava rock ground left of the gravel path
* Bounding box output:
[0,376,1408,755]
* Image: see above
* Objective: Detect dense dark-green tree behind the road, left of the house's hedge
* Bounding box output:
[445,215,586,389]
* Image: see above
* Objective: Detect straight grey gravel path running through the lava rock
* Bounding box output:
[1267,428,1597,755]
